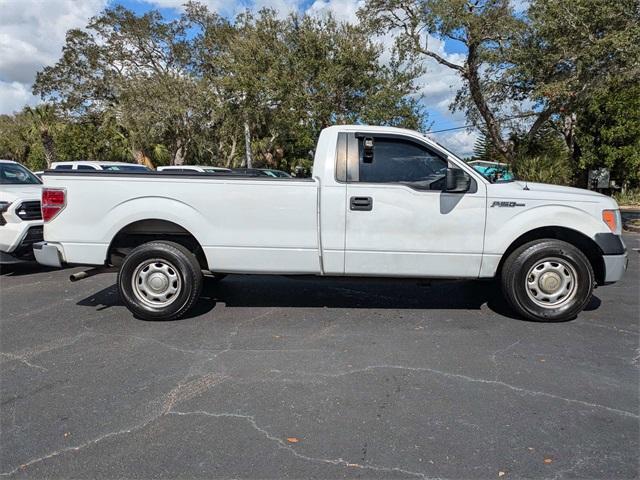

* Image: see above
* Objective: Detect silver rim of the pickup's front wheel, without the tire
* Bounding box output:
[525,258,578,308]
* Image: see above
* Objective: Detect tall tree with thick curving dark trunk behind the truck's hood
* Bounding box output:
[359,0,528,160]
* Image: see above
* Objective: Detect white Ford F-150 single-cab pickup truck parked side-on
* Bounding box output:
[34,126,627,321]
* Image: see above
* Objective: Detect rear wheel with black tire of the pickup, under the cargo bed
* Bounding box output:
[118,241,202,320]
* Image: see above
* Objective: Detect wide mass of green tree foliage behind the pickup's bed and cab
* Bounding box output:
[22,3,425,170]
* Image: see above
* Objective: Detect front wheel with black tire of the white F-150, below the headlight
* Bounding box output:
[501,239,595,322]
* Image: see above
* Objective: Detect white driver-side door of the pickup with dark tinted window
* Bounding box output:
[345,133,486,278]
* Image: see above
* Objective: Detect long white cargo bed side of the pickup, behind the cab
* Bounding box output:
[43,171,320,274]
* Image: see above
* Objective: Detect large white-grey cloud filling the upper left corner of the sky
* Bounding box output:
[0,0,106,113]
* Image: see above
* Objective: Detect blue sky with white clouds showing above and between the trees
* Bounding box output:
[0,0,477,156]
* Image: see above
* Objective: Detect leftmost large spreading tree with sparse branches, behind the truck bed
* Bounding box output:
[34,6,198,167]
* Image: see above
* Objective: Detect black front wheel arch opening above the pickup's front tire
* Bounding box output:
[496,226,606,285]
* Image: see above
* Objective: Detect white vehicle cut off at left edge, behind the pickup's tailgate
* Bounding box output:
[0,160,43,265]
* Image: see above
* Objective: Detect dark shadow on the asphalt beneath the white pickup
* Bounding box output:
[77,275,601,320]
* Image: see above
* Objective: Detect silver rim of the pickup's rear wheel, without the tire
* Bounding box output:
[131,258,182,308]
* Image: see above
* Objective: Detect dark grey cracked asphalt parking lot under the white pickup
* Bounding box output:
[0,235,640,479]
